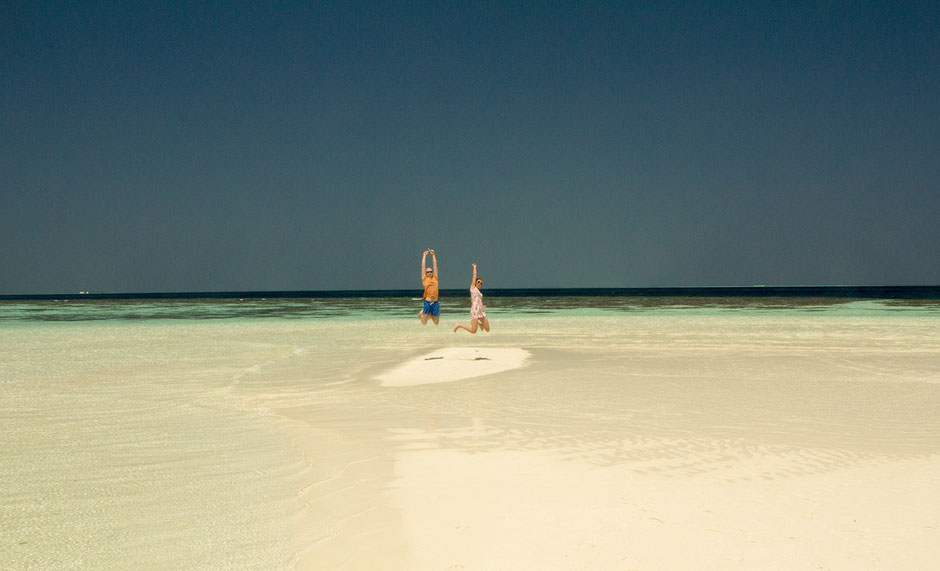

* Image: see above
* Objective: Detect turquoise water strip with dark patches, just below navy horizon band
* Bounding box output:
[0,296,940,326]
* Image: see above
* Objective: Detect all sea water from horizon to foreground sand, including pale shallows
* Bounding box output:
[0,286,940,569]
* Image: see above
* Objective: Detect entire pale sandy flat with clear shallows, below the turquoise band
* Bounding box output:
[0,304,940,571]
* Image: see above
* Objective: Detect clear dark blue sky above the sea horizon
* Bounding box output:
[0,0,940,294]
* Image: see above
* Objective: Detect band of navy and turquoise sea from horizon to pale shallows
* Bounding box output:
[0,286,940,323]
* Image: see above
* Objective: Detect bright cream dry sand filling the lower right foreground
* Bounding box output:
[393,442,940,569]
